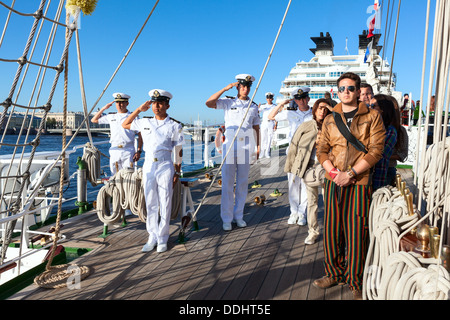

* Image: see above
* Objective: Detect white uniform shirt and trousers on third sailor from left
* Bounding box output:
[216,98,261,223]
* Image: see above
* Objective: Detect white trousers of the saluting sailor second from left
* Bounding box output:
[142,159,175,244]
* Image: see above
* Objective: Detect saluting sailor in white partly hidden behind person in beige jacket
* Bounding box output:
[269,87,312,226]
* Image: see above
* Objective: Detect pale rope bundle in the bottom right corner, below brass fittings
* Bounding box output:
[379,251,450,300]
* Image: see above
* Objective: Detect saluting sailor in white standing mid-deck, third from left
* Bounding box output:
[206,74,261,231]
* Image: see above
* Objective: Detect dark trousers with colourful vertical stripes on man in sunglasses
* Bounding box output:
[323,179,372,290]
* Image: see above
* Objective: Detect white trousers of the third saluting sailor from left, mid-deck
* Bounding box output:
[220,144,250,223]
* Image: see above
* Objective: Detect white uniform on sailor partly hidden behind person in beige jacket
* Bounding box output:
[275,104,313,221]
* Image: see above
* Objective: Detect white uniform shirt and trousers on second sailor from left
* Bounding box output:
[131,116,184,244]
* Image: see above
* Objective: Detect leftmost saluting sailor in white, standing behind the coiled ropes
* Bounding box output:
[91,93,142,175]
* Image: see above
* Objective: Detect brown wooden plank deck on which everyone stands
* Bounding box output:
[10,151,411,301]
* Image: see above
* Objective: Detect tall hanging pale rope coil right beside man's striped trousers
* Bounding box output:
[363,186,418,300]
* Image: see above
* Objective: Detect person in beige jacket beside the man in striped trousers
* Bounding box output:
[284,99,332,244]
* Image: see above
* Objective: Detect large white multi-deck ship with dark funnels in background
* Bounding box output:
[276,30,402,106]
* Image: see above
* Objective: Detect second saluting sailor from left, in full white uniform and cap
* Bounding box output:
[123,89,184,252]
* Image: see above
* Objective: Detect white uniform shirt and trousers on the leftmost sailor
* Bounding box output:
[98,112,136,175]
